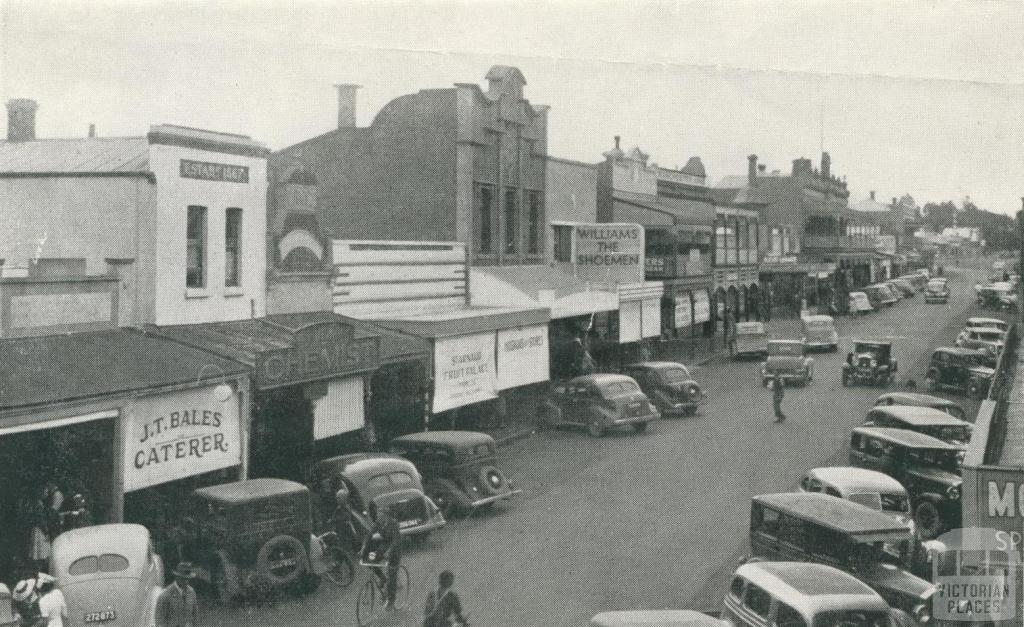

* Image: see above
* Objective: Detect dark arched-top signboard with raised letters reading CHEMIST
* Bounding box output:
[255,322,380,389]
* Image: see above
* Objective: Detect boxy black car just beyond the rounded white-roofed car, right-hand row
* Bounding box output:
[850,426,964,540]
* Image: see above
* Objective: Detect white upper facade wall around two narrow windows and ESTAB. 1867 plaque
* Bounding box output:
[150,144,266,325]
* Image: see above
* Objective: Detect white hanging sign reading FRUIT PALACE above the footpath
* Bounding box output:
[433,332,498,413]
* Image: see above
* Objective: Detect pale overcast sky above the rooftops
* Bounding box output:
[6,0,1024,213]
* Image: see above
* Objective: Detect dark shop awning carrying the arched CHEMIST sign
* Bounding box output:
[154,311,430,389]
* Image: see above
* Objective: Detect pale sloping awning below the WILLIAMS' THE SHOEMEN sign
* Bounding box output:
[469,265,620,320]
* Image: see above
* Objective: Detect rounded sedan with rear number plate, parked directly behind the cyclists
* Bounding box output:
[309,453,445,536]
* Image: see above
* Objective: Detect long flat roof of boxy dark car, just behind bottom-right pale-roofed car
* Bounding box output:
[754,492,907,536]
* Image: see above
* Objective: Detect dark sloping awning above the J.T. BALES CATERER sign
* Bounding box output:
[0,328,248,415]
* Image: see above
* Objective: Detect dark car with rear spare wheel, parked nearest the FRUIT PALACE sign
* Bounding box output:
[390,431,522,517]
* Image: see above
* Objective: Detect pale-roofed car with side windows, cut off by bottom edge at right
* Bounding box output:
[721,560,899,627]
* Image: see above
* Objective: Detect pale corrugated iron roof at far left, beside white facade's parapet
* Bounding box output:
[0,137,150,173]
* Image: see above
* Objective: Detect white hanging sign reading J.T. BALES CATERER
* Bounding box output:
[124,385,242,492]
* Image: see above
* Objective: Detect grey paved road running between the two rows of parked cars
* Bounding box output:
[206,268,995,627]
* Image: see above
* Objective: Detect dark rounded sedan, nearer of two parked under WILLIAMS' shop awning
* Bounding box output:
[537,374,660,437]
